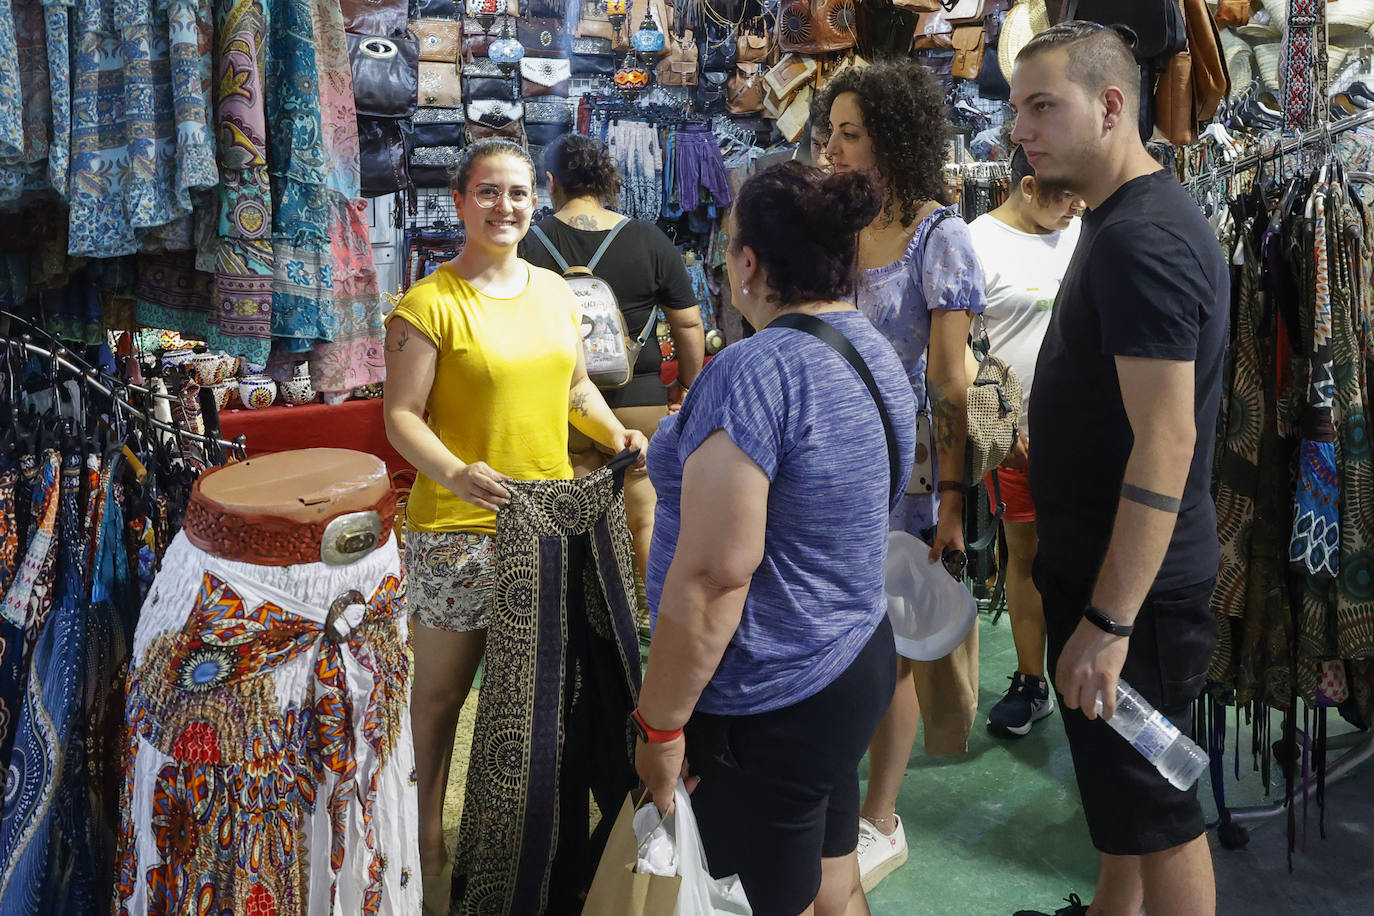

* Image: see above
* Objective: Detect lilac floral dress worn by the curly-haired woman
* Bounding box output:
[857,207,988,537]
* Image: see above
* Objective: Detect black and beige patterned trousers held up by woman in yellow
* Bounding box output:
[451,457,640,916]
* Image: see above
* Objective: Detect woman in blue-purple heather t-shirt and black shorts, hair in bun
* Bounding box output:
[635,162,915,916]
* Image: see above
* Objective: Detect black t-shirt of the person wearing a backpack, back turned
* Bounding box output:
[519,216,697,407]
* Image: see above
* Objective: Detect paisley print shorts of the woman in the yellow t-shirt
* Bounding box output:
[405,531,496,632]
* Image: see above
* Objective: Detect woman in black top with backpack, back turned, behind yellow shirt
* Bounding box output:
[519,133,706,596]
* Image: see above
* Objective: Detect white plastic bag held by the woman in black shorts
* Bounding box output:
[635,780,753,916]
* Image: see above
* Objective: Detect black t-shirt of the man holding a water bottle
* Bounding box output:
[1031,172,1231,592]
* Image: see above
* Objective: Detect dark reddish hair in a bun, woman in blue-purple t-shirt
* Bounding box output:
[730,162,882,306]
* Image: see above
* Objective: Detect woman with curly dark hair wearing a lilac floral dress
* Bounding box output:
[826,60,985,890]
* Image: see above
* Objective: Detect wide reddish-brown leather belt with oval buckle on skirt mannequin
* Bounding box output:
[183,481,397,566]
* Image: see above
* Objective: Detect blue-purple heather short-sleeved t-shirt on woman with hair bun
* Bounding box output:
[649,312,915,715]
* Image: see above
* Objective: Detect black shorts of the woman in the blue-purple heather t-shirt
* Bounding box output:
[687,615,897,916]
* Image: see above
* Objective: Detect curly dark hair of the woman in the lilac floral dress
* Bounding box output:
[824,59,949,225]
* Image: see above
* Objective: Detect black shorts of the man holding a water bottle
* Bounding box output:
[1035,563,1216,856]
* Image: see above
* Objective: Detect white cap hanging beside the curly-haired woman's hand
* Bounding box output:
[883,531,978,662]
